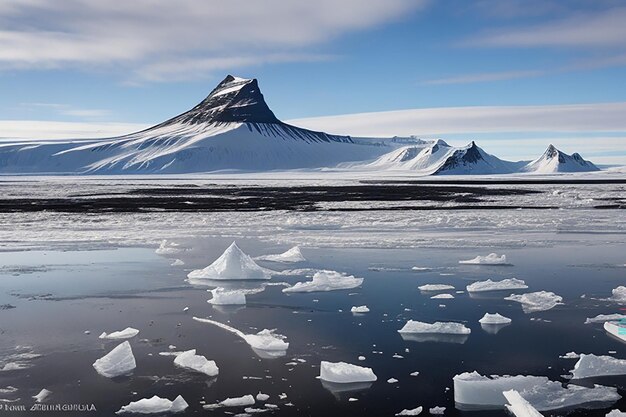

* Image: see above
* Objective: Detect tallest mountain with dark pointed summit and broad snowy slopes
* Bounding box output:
[0,75,398,174]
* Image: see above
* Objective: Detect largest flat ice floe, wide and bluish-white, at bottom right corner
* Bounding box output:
[453,371,621,411]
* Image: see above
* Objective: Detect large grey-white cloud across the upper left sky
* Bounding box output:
[0,0,426,80]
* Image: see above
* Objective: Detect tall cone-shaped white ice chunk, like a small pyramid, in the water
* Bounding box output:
[187,242,274,284]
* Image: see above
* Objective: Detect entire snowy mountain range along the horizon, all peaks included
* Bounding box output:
[0,75,598,175]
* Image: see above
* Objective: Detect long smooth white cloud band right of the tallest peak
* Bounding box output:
[290,102,626,136]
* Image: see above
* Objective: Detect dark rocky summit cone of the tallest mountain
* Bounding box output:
[162,75,279,125]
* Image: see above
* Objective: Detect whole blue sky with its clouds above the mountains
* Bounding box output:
[0,0,626,164]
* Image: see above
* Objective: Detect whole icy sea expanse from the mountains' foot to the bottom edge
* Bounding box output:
[0,177,626,417]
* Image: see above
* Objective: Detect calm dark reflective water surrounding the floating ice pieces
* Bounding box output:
[0,236,626,416]
